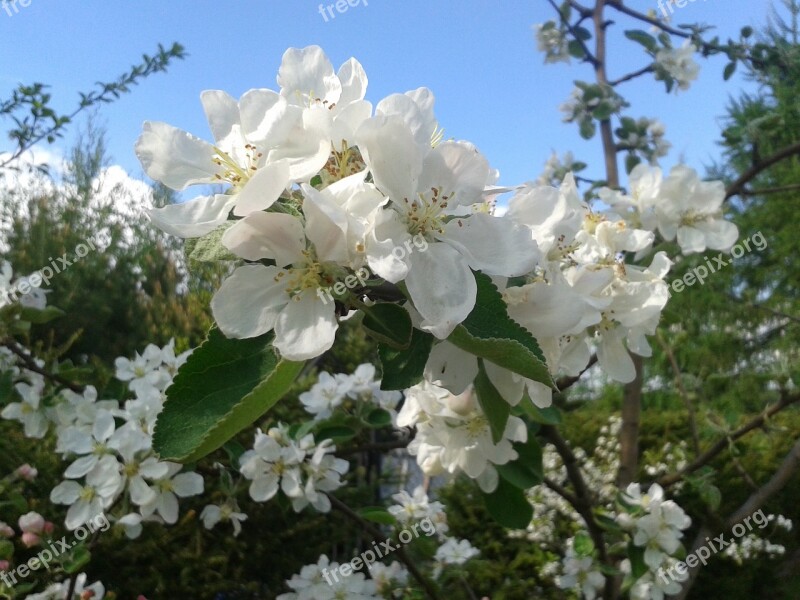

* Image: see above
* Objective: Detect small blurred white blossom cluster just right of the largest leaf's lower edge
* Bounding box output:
[300,363,403,421]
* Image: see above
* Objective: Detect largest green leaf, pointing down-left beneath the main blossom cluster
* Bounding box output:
[153,328,304,463]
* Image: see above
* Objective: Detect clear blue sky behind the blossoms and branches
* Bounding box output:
[0,0,770,184]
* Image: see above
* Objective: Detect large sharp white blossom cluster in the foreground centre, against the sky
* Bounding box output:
[136,46,538,360]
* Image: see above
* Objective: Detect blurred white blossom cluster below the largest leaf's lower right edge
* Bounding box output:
[239,425,350,513]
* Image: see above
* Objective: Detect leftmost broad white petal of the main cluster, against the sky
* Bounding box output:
[136,121,217,190]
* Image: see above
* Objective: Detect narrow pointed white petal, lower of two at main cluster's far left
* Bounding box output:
[146,194,236,238]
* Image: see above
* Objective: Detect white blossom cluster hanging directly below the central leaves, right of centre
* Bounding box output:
[397,382,528,492]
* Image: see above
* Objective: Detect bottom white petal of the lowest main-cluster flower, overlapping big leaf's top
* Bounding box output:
[274,290,339,361]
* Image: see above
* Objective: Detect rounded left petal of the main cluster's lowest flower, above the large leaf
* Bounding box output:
[211,265,290,339]
